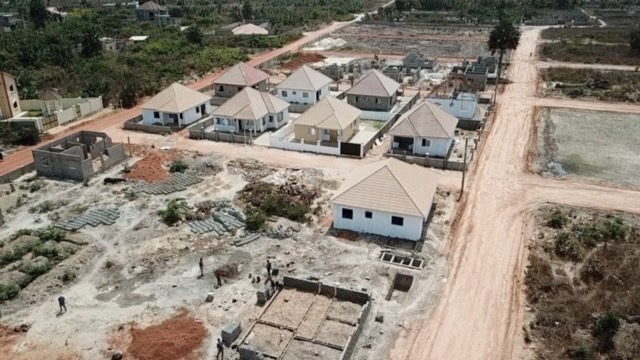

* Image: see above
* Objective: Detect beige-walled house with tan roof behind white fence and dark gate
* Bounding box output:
[293,96,361,144]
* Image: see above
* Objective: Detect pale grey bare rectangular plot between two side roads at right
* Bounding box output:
[535,109,640,188]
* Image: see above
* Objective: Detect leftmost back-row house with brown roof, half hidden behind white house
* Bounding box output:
[213,62,269,98]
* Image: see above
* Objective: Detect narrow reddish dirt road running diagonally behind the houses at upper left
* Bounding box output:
[0,20,357,179]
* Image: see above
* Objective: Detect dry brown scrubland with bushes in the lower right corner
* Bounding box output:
[525,206,640,360]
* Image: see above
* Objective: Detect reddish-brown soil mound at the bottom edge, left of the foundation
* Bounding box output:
[127,313,207,360]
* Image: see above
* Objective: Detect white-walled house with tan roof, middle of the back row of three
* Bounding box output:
[276,65,333,105]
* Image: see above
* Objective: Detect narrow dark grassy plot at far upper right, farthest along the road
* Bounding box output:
[540,27,631,44]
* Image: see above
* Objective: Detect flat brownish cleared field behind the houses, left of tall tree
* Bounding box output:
[332,24,489,58]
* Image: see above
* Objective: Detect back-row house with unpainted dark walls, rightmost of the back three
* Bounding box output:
[346,70,400,111]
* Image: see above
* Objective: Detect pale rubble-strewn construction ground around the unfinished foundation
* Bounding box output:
[0,146,455,360]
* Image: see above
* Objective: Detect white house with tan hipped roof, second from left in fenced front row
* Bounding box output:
[213,87,289,133]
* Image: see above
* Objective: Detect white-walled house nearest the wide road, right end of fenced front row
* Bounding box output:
[388,100,458,157]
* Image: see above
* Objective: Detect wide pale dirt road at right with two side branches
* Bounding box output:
[392,29,640,360]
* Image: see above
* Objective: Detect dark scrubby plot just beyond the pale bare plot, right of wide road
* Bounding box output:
[542,68,640,102]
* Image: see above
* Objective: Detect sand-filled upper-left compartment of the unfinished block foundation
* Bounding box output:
[262,289,315,329]
